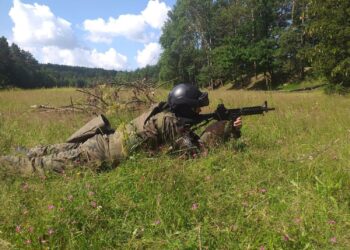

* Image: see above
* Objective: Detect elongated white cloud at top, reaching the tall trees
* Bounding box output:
[84,0,170,43]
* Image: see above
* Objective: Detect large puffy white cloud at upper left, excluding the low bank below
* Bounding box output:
[9,0,76,48]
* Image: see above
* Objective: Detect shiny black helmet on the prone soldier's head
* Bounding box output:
[168,83,209,111]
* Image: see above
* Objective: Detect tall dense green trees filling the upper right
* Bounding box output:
[160,0,350,89]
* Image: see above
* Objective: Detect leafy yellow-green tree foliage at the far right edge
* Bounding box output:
[307,0,350,87]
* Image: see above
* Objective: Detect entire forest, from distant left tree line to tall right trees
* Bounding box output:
[0,0,350,92]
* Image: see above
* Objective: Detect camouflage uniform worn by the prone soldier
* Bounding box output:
[0,104,239,175]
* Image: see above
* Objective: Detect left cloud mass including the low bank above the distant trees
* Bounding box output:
[9,0,127,70]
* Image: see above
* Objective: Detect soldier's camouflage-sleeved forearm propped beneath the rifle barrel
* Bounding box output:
[200,121,241,145]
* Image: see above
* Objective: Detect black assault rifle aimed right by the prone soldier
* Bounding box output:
[188,101,275,125]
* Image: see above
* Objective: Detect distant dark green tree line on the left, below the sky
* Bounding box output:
[0,37,159,88]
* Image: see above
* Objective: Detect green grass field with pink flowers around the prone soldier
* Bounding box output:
[0,89,350,250]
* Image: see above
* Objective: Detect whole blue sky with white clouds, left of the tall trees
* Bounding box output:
[0,0,176,70]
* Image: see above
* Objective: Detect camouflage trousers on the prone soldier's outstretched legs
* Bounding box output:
[0,134,121,175]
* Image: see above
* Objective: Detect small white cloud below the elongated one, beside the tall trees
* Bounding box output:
[136,43,162,67]
